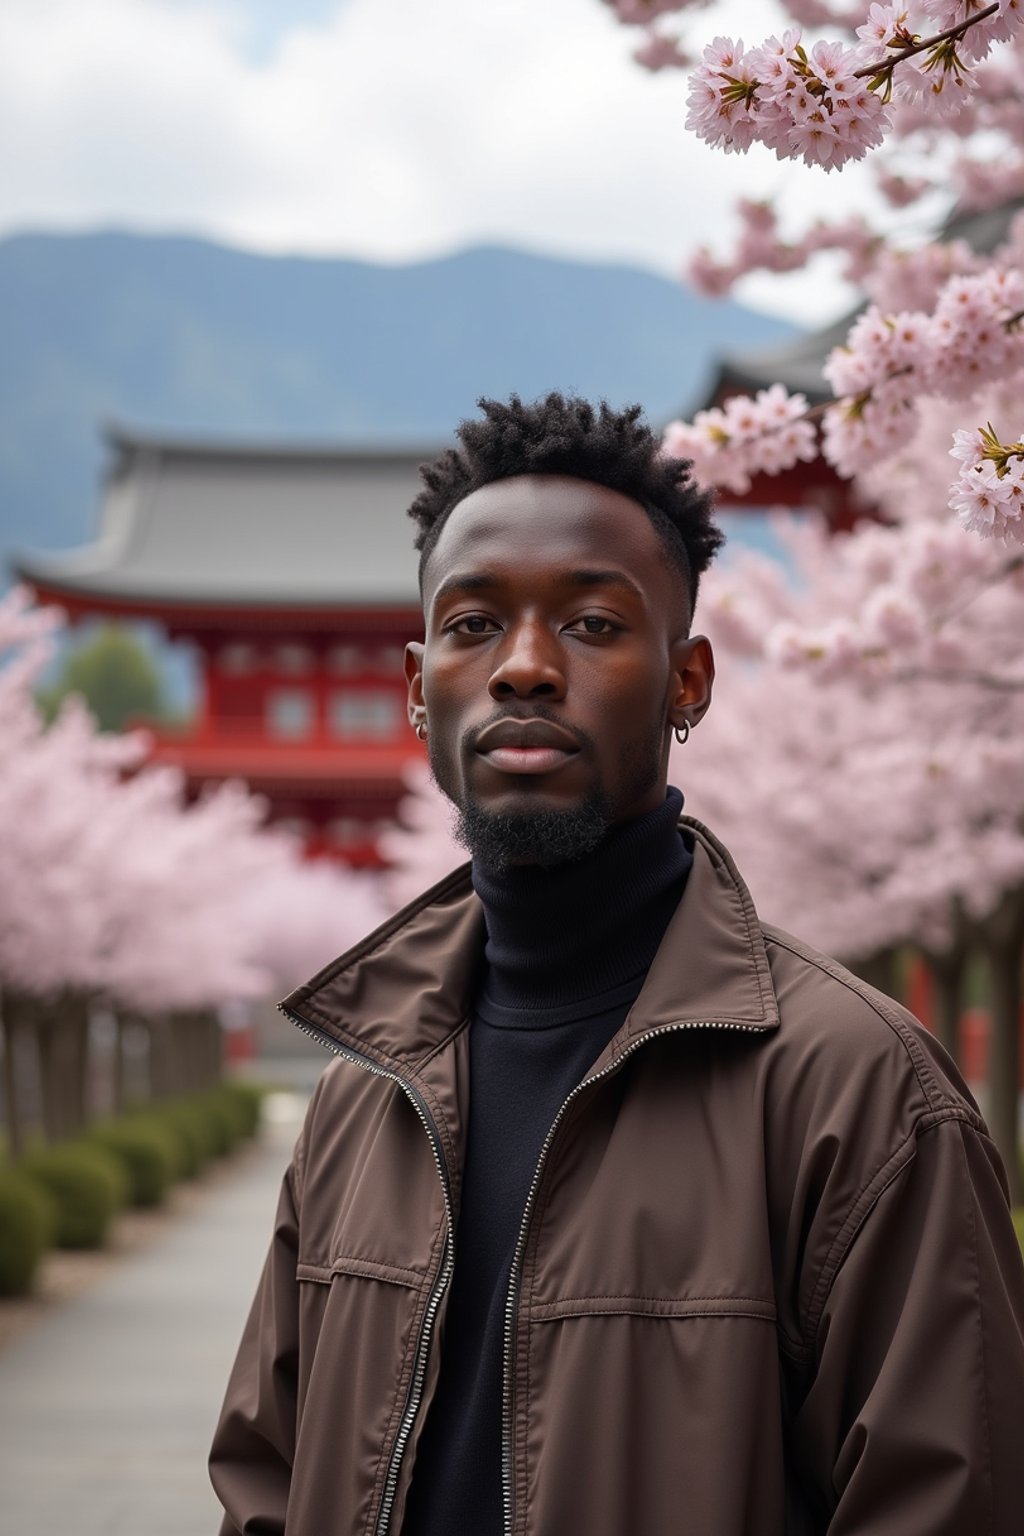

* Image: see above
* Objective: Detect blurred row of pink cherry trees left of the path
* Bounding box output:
[0,591,376,1140]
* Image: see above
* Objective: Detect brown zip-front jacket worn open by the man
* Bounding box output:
[210,819,1024,1536]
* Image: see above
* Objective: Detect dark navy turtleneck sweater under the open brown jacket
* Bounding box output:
[402,788,691,1536]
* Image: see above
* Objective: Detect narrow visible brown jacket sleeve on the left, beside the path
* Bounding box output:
[210,1164,298,1536]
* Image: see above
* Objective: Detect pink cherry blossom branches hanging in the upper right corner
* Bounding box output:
[606,0,1024,544]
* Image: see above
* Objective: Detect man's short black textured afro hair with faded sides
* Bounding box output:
[408,392,725,613]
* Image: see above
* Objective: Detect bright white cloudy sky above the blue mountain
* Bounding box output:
[0,0,896,321]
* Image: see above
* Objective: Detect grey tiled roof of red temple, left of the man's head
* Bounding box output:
[12,427,438,607]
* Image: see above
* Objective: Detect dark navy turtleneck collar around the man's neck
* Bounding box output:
[473,786,692,1009]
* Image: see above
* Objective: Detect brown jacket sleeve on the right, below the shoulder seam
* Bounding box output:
[792,1115,1024,1536]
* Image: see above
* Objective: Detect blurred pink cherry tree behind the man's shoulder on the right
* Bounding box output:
[676,473,1024,1198]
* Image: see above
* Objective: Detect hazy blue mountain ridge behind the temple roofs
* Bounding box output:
[0,233,792,574]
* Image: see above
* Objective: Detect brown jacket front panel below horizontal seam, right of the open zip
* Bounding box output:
[513,1295,785,1536]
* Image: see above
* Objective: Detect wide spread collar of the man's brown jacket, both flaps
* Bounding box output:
[279,816,778,1074]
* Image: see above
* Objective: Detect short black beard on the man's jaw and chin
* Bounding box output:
[428,708,663,872]
